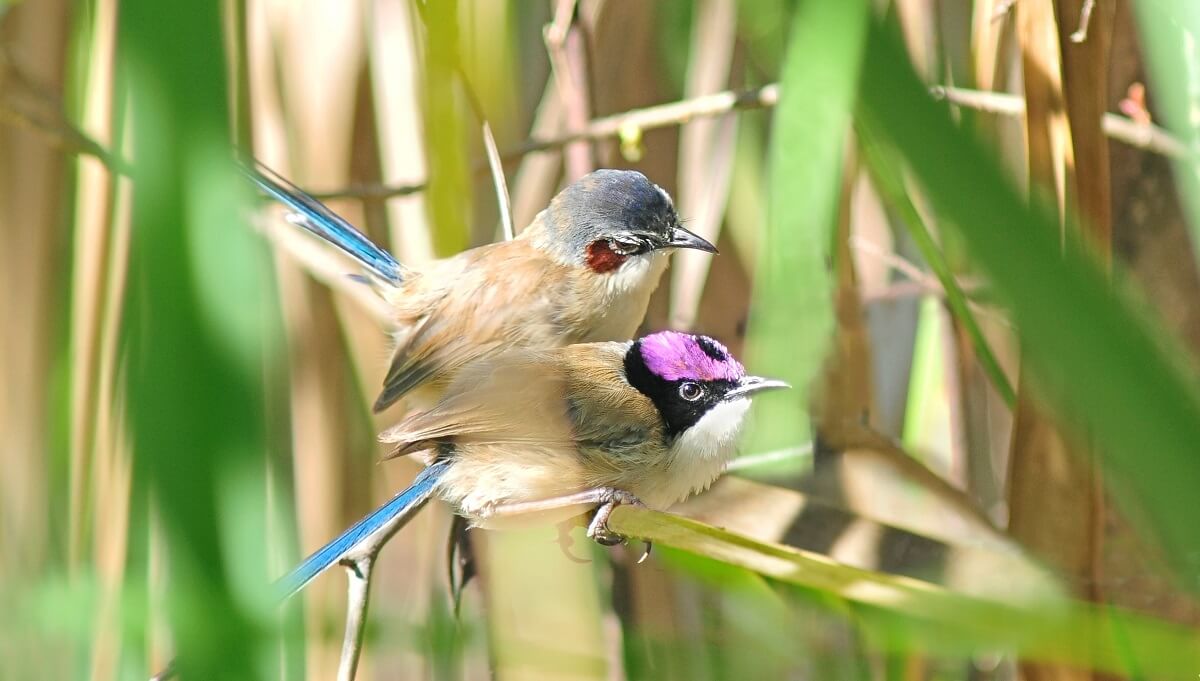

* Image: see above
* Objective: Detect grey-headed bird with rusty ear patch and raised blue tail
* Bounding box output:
[245,164,716,411]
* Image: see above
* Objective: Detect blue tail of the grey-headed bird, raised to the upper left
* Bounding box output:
[241,161,404,284]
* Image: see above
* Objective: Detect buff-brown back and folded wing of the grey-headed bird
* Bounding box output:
[374,240,564,411]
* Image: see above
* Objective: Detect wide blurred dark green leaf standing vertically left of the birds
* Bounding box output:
[120,0,281,679]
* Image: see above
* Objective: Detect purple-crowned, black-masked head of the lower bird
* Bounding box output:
[625,331,788,438]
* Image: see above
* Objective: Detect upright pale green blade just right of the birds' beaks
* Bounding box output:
[745,0,868,451]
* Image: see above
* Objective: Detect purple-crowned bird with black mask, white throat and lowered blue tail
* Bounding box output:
[277,331,787,597]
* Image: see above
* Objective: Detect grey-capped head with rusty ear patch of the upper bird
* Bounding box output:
[529,169,716,275]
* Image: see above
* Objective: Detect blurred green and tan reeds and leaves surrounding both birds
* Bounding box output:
[0,0,1200,680]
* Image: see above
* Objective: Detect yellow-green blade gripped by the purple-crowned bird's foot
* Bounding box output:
[610,506,1200,679]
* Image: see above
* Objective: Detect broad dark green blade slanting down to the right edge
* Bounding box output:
[860,21,1200,591]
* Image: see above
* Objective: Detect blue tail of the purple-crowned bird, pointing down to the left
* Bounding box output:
[272,460,450,601]
